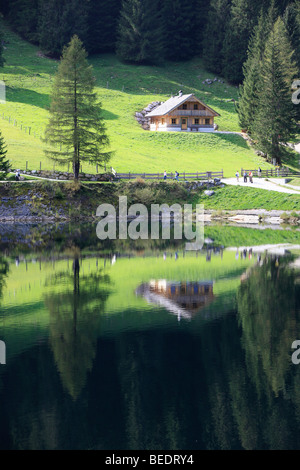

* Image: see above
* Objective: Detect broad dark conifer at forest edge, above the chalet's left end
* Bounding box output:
[116,0,164,64]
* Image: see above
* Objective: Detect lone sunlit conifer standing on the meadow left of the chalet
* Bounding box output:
[45,35,111,180]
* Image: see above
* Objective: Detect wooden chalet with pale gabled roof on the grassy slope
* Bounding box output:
[146,91,220,132]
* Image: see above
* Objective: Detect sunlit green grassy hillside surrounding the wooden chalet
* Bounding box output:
[0,21,282,176]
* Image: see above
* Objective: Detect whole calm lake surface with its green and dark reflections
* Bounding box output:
[0,227,300,450]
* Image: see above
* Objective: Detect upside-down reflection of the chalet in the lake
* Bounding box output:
[136,279,215,320]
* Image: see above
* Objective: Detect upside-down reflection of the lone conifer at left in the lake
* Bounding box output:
[45,254,110,399]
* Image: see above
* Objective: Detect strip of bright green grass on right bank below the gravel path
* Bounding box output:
[198,186,300,211]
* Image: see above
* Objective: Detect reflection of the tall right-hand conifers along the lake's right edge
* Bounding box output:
[237,259,300,449]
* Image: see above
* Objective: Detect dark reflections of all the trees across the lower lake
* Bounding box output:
[0,255,300,450]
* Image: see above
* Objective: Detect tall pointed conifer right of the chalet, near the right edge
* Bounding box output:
[253,18,297,164]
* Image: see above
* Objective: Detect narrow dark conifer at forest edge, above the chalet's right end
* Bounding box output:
[203,0,231,74]
